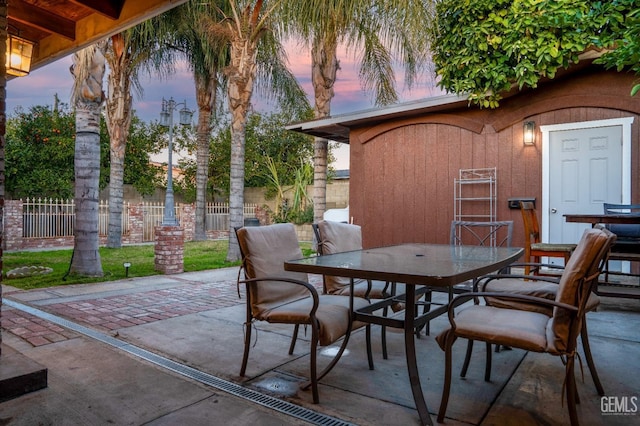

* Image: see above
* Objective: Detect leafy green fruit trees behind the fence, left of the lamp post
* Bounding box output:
[5,104,161,199]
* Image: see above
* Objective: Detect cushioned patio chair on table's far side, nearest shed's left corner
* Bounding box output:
[312,220,398,359]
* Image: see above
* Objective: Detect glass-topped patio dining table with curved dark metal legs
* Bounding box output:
[284,244,524,425]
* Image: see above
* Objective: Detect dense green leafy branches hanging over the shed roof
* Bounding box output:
[433,0,637,108]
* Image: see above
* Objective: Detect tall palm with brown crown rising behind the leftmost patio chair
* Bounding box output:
[203,0,306,261]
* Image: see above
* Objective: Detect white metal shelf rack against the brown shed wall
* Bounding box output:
[453,167,497,222]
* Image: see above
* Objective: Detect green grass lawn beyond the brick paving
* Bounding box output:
[2,240,313,290]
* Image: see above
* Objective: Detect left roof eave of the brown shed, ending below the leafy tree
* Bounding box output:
[285,95,469,143]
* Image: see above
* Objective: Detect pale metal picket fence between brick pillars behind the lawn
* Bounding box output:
[22,198,257,241]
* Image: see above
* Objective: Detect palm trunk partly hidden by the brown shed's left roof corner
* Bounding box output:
[311,34,340,223]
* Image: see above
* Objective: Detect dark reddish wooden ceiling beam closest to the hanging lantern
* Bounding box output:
[8,0,76,40]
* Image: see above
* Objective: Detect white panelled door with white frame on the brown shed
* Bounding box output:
[538,117,633,248]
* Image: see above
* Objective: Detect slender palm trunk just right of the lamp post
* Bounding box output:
[194,74,218,241]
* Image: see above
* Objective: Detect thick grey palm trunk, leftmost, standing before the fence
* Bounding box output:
[69,42,106,277]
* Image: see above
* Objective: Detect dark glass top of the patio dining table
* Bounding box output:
[285,243,523,287]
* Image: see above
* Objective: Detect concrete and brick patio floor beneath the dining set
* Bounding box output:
[0,268,640,426]
